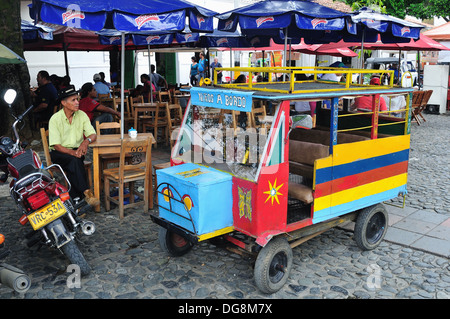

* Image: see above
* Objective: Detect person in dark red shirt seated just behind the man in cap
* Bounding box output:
[80,82,120,133]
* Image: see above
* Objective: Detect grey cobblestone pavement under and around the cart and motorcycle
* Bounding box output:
[0,115,450,301]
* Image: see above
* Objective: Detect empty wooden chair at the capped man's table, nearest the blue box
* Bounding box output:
[103,138,153,219]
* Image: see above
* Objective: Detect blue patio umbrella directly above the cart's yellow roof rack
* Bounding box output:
[216,0,350,69]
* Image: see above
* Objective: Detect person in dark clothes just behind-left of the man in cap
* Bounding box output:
[31,70,58,123]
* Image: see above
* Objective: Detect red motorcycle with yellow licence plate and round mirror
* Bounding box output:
[0,89,95,275]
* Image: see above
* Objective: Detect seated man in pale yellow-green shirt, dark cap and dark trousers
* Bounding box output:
[48,85,100,206]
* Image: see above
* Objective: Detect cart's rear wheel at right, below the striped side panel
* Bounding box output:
[354,204,388,250]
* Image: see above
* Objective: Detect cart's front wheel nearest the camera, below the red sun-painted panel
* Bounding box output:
[254,237,293,294]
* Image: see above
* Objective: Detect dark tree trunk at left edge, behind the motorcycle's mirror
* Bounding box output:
[0,0,32,142]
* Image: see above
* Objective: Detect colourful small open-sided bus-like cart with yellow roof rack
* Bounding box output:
[152,68,412,293]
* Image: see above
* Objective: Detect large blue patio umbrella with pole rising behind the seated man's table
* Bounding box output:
[30,0,217,138]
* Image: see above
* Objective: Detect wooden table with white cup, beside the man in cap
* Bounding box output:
[89,133,156,212]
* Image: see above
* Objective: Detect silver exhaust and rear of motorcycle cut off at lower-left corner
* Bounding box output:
[0,234,31,293]
